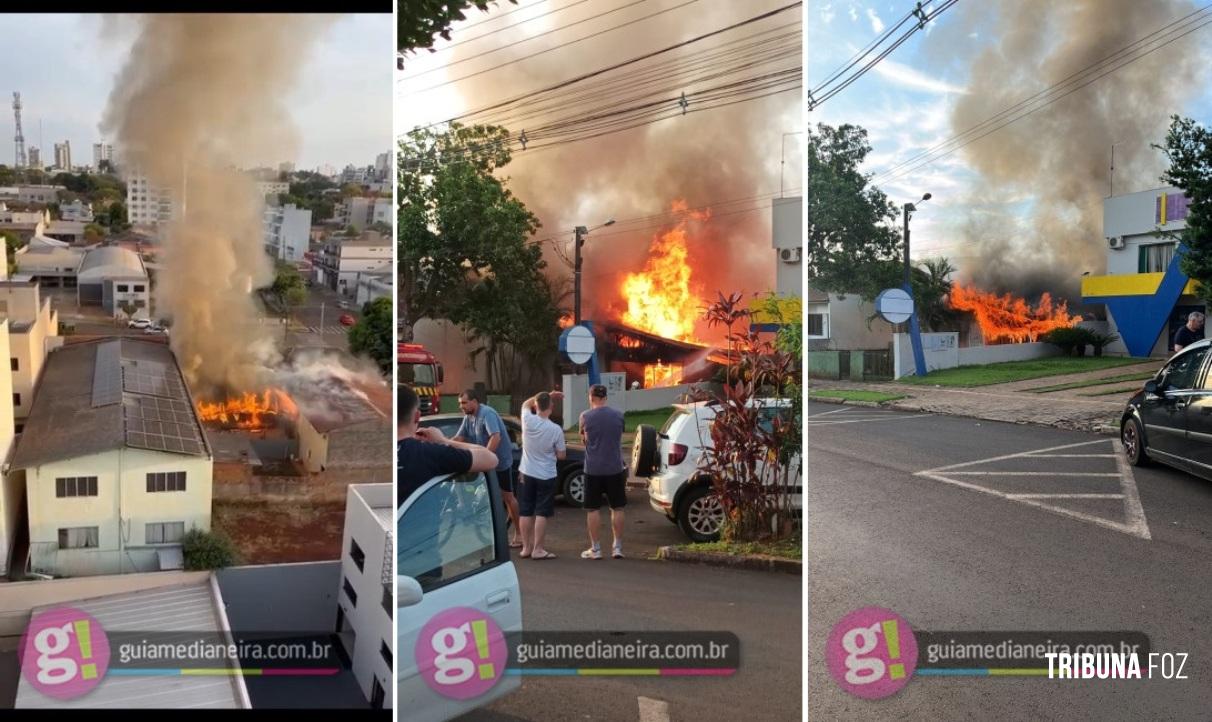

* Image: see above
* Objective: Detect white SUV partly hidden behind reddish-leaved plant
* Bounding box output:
[630,399,804,542]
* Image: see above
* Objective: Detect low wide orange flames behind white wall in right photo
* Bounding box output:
[950,283,1081,344]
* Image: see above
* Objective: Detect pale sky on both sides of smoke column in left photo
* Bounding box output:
[0,15,395,170]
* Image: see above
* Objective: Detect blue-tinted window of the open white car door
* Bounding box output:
[396,474,497,591]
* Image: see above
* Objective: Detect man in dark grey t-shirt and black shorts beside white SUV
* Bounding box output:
[581,384,627,560]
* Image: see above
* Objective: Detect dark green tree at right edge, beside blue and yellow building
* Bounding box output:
[1154,115,1212,300]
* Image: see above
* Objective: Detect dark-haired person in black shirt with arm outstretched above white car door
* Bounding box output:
[395,386,497,504]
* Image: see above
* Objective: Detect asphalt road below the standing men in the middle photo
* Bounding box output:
[461,489,802,722]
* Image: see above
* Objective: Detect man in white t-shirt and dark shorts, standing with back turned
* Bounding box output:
[518,391,567,560]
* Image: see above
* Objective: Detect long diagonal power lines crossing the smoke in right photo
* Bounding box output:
[873,5,1212,183]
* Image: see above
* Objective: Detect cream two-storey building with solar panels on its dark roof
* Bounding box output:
[10,337,212,577]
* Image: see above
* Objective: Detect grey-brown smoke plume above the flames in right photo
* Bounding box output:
[934,0,1200,299]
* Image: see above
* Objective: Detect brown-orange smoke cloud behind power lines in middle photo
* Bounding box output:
[450,0,802,339]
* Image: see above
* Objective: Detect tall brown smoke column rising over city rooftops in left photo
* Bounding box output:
[102,15,327,391]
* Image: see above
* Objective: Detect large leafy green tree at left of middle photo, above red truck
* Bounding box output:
[396,124,559,389]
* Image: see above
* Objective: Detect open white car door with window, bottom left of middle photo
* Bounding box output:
[396,474,522,722]
